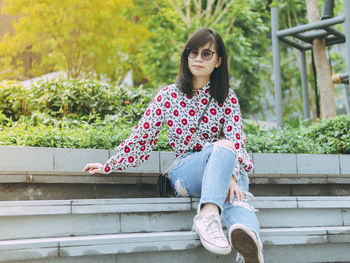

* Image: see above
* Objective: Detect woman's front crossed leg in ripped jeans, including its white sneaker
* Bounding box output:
[169,142,235,254]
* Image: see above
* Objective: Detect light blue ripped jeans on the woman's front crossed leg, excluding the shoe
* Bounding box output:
[169,141,235,210]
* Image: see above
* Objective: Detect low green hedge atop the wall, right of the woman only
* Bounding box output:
[245,115,350,154]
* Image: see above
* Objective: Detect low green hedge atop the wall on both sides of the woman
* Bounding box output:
[0,109,350,154]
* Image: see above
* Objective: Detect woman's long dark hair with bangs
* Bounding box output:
[176,28,230,103]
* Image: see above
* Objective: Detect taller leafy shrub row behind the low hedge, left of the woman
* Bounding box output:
[0,79,157,121]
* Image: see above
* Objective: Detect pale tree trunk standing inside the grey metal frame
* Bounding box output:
[306,0,336,119]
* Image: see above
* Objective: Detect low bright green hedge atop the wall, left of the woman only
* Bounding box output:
[0,113,170,151]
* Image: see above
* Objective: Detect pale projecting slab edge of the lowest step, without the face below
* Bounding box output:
[0,227,350,261]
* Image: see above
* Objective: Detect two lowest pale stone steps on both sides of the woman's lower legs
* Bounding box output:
[0,197,350,262]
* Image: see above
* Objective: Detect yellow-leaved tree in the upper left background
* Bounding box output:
[0,0,149,80]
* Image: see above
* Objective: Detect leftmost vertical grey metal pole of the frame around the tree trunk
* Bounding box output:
[271,6,284,128]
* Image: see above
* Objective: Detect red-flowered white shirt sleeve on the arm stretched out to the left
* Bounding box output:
[102,89,166,174]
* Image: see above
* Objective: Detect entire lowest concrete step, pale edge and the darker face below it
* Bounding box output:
[0,227,350,263]
